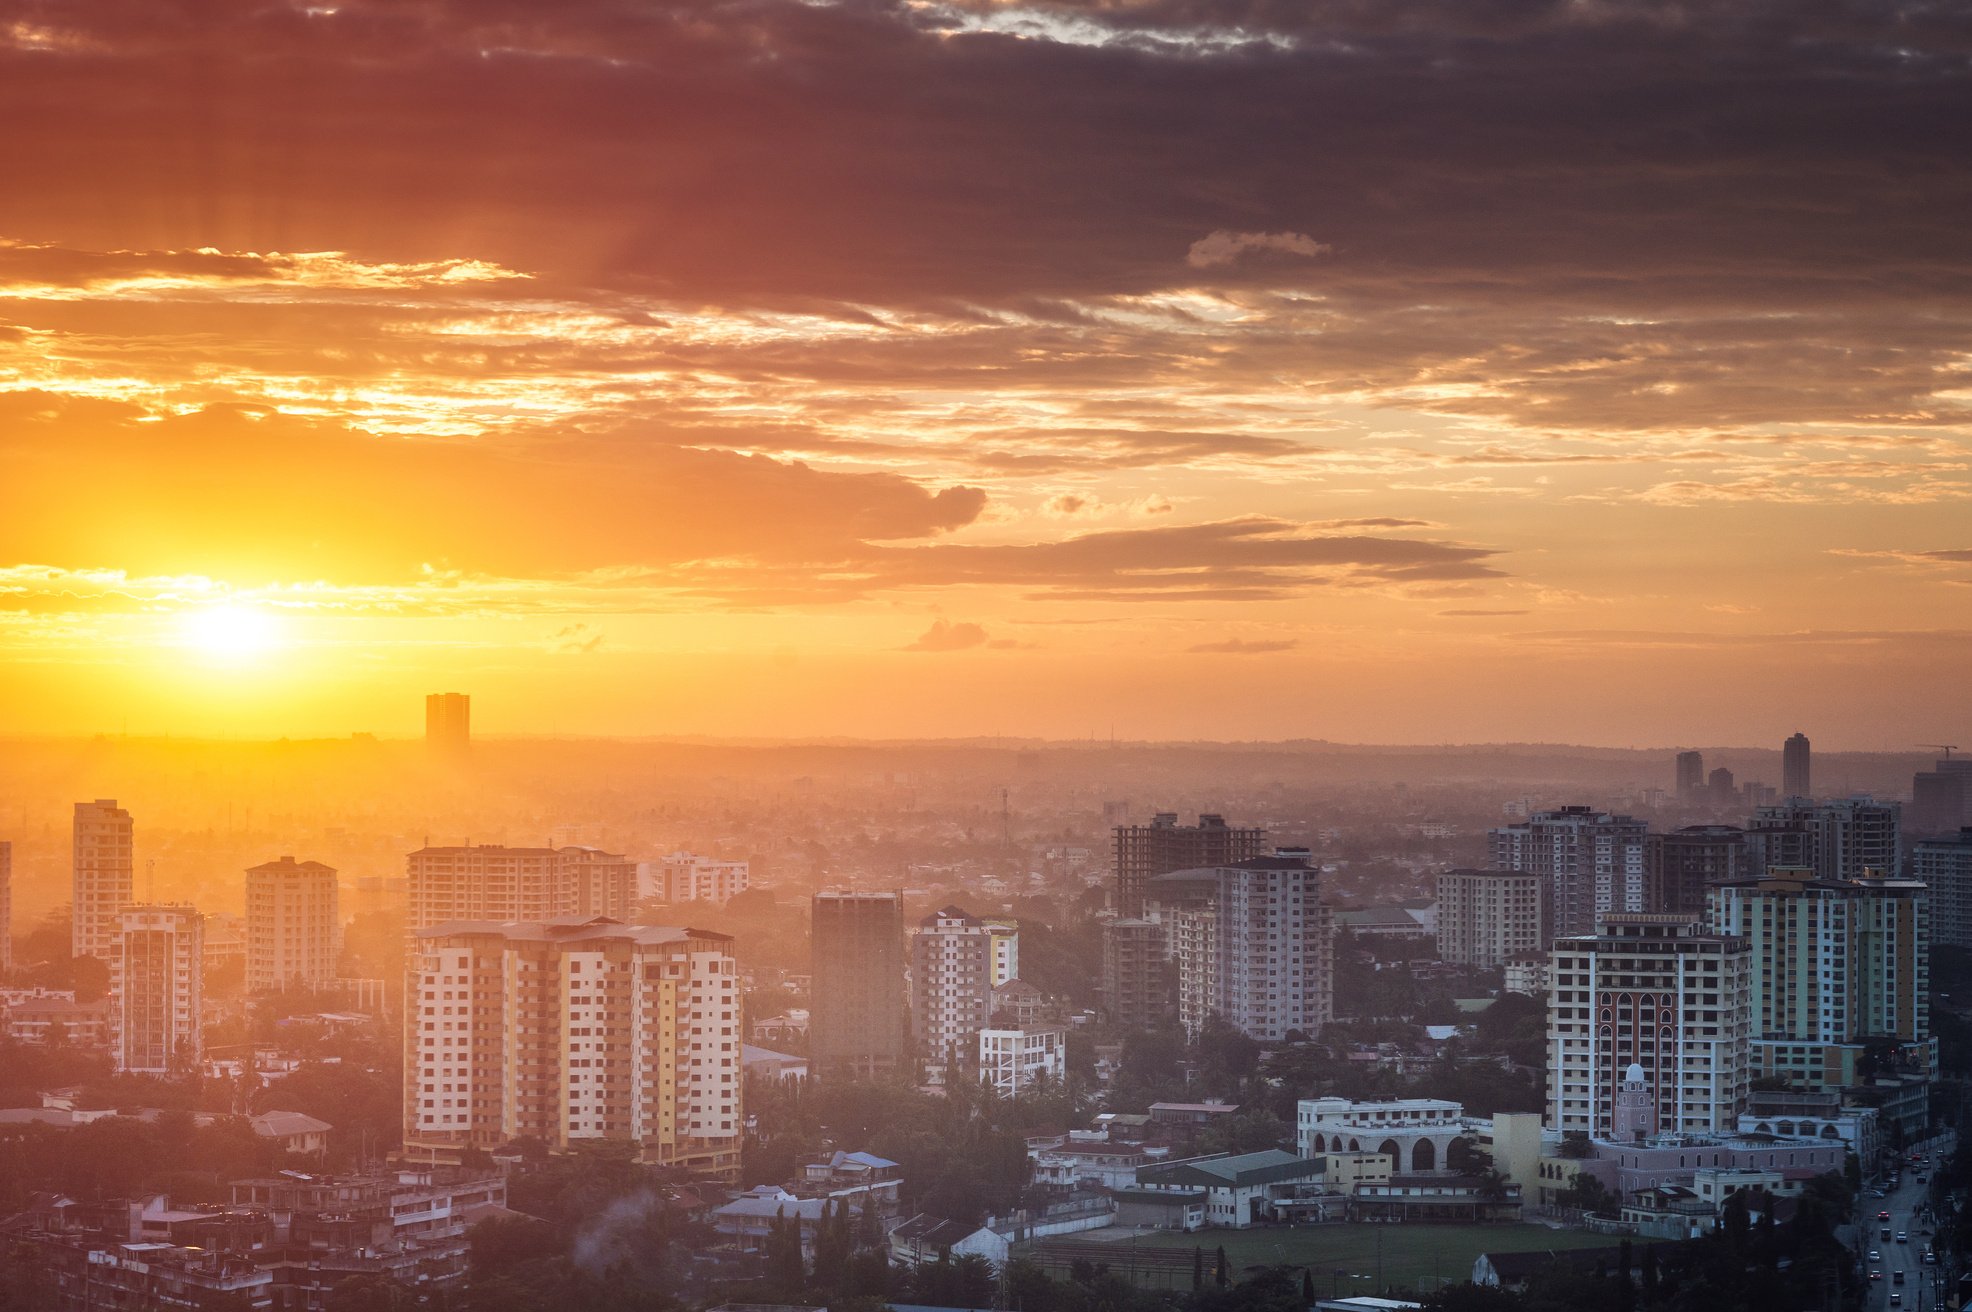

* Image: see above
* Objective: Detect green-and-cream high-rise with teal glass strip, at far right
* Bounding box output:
[1710,868,1937,1089]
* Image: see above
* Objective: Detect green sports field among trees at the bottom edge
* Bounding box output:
[1023,1225,1619,1296]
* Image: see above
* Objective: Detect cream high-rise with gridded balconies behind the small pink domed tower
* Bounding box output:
[1548,911,1751,1138]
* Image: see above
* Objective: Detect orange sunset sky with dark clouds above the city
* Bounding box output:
[0,0,1972,750]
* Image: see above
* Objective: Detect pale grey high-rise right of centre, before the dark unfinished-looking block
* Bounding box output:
[1169,854,1335,1042]
